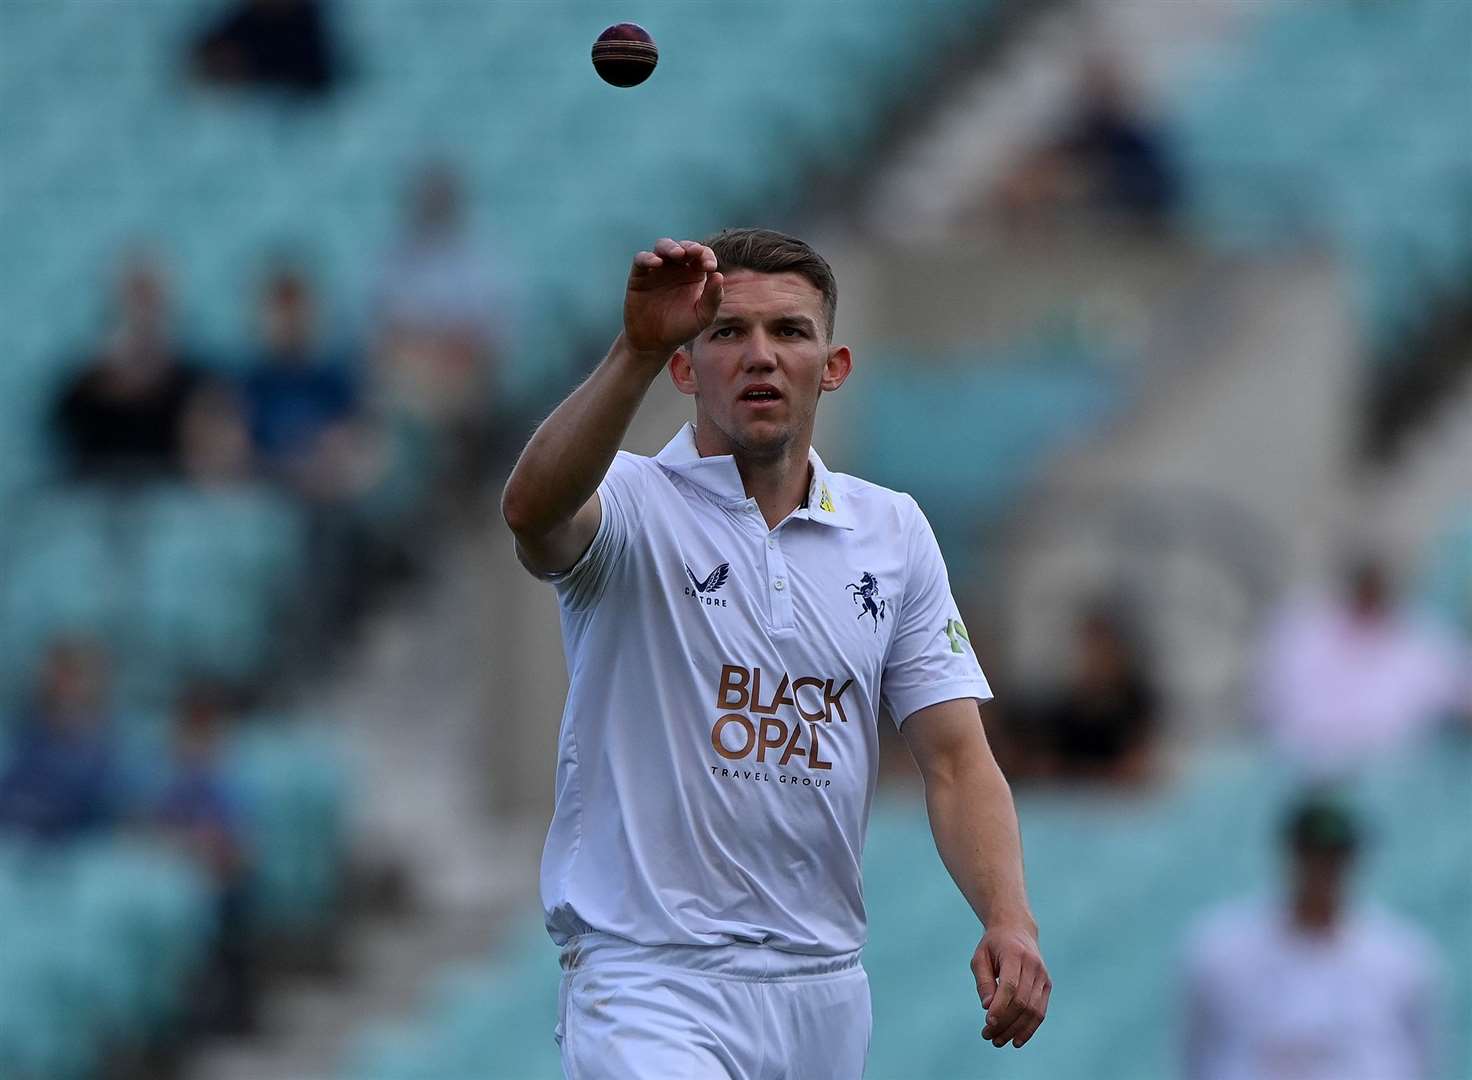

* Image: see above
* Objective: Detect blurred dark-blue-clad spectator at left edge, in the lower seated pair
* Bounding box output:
[0,642,124,842]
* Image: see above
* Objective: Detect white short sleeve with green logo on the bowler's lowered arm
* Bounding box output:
[879,499,992,727]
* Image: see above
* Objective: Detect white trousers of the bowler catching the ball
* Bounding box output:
[555,933,873,1080]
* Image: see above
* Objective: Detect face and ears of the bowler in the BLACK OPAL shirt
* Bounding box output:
[670,271,852,459]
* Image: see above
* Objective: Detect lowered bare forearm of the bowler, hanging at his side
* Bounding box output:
[924,756,1038,934]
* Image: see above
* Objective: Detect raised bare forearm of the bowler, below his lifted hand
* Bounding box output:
[502,334,667,534]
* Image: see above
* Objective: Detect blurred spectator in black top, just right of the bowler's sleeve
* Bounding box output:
[1038,605,1158,783]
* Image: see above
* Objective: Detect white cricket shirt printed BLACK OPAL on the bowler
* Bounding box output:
[529,424,992,955]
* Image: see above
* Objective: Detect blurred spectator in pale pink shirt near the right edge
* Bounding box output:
[1259,561,1472,772]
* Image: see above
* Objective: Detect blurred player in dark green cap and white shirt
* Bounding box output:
[1183,795,1443,1080]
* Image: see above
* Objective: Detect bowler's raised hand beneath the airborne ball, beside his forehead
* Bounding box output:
[624,237,724,358]
